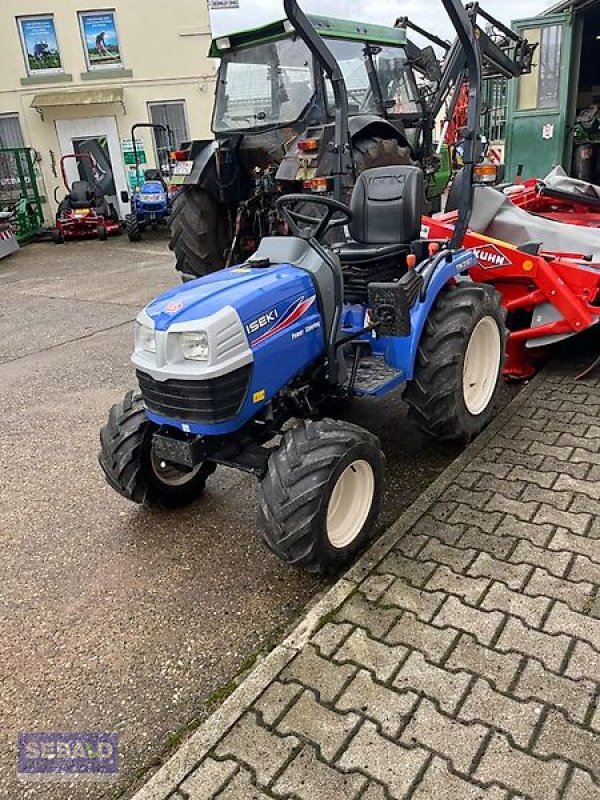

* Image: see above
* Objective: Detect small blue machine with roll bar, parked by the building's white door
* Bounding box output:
[121,122,173,242]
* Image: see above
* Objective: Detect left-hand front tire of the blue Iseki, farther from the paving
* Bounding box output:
[98,392,216,508]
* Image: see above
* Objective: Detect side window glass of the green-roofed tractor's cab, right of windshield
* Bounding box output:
[326,39,419,116]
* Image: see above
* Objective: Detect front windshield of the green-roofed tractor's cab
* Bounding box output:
[213,39,315,133]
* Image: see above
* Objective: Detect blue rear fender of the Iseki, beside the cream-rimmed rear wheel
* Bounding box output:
[385,250,477,381]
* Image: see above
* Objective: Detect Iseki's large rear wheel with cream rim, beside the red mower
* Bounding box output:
[404,283,507,443]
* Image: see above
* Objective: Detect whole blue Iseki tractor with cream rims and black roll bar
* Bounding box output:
[99,0,506,573]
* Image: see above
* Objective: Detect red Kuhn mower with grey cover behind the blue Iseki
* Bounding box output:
[422,170,600,379]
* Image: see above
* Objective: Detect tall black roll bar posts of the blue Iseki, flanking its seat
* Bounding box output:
[283,0,482,248]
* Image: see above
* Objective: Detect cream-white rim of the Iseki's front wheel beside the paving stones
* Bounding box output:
[327,459,375,550]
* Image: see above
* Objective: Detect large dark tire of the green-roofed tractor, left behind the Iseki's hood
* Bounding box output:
[169,186,229,278]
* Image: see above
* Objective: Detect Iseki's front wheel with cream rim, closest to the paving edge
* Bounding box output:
[258,419,385,574]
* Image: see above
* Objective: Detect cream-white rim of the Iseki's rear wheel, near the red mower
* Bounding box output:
[463,317,502,417]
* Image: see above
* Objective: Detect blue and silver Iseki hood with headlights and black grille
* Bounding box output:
[132,260,324,435]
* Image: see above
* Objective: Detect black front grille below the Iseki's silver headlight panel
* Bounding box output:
[137,364,252,424]
